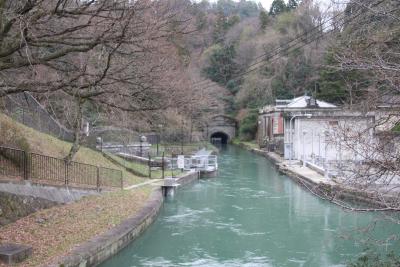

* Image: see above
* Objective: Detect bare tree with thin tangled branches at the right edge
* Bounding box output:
[310,0,400,214]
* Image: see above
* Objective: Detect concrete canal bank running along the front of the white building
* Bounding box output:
[236,142,398,211]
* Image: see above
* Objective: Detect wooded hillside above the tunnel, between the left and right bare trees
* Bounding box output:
[183,0,332,139]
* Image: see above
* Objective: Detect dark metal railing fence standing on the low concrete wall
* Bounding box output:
[0,146,123,189]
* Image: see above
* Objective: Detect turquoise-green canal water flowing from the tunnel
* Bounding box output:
[101,147,400,267]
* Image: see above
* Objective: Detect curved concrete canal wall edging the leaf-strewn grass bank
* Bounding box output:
[48,190,163,267]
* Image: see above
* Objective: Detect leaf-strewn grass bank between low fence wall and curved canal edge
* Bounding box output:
[0,187,152,267]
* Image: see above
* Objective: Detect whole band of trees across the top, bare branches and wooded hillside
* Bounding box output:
[0,0,400,147]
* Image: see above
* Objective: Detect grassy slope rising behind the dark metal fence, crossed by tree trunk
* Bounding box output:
[0,113,143,184]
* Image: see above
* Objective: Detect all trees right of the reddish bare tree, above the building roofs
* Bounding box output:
[183,0,399,139]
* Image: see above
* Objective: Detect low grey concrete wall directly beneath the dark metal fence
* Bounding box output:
[0,181,99,203]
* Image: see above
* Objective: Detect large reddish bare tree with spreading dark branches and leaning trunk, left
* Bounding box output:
[0,0,194,160]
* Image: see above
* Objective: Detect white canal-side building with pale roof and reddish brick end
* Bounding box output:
[258,96,375,174]
